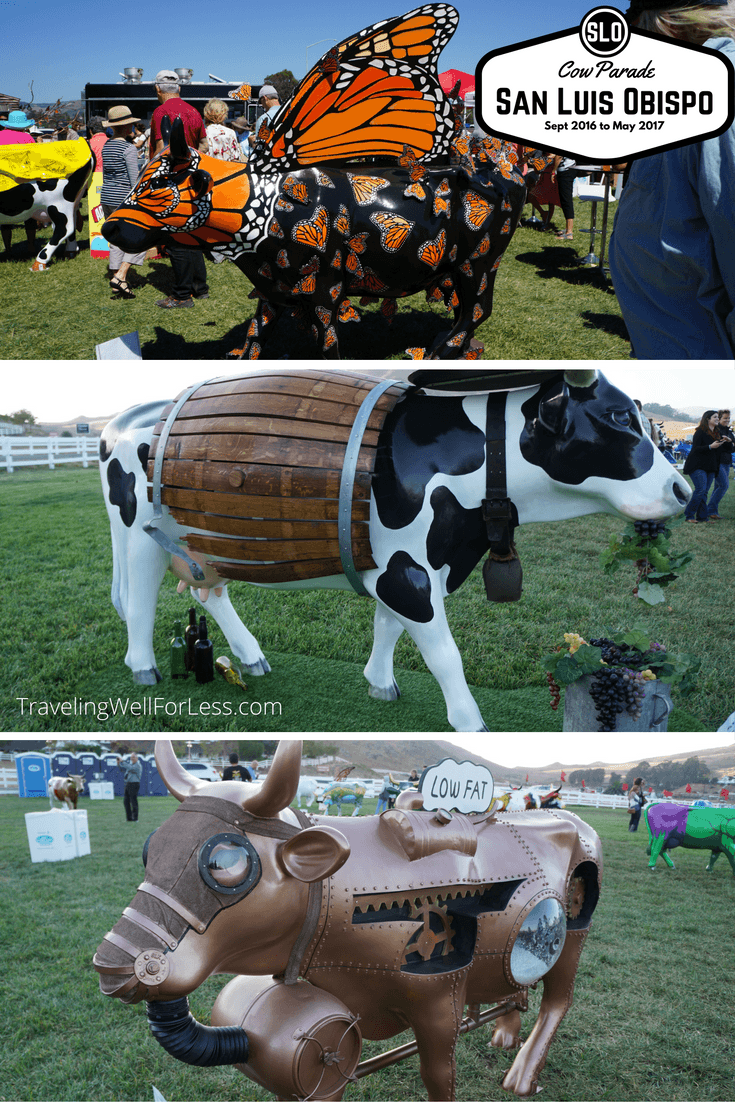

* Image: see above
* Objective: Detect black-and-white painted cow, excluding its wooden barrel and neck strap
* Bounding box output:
[100,371,691,731]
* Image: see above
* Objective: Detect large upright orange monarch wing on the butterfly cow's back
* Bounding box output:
[249,3,458,174]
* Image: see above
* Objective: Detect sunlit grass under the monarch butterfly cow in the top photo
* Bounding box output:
[0,199,630,360]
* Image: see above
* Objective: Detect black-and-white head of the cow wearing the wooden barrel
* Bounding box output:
[520,370,691,520]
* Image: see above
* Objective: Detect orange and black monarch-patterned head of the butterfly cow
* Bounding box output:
[102,119,250,252]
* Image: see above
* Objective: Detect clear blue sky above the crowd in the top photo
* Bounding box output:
[0,0,628,102]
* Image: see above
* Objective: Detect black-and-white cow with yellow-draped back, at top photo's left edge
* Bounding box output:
[0,145,95,272]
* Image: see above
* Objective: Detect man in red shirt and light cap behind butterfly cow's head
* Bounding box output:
[150,69,209,310]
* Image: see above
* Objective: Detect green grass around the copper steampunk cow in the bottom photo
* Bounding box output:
[0,796,735,1102]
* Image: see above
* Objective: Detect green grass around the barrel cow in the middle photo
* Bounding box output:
[0,467,735,734]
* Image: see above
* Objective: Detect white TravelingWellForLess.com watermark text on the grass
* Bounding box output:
[15,696,282,723]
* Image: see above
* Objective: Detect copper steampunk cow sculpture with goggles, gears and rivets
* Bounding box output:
[94,741,602,1100]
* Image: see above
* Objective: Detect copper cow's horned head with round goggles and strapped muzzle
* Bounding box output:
[94,741,349,1003]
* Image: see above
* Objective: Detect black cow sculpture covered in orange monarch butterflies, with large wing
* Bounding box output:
[104,3,539,359]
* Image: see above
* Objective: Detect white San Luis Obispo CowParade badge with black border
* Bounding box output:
[476,8,735,164]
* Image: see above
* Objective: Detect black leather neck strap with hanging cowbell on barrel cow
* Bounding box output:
[483,392,523,603]
